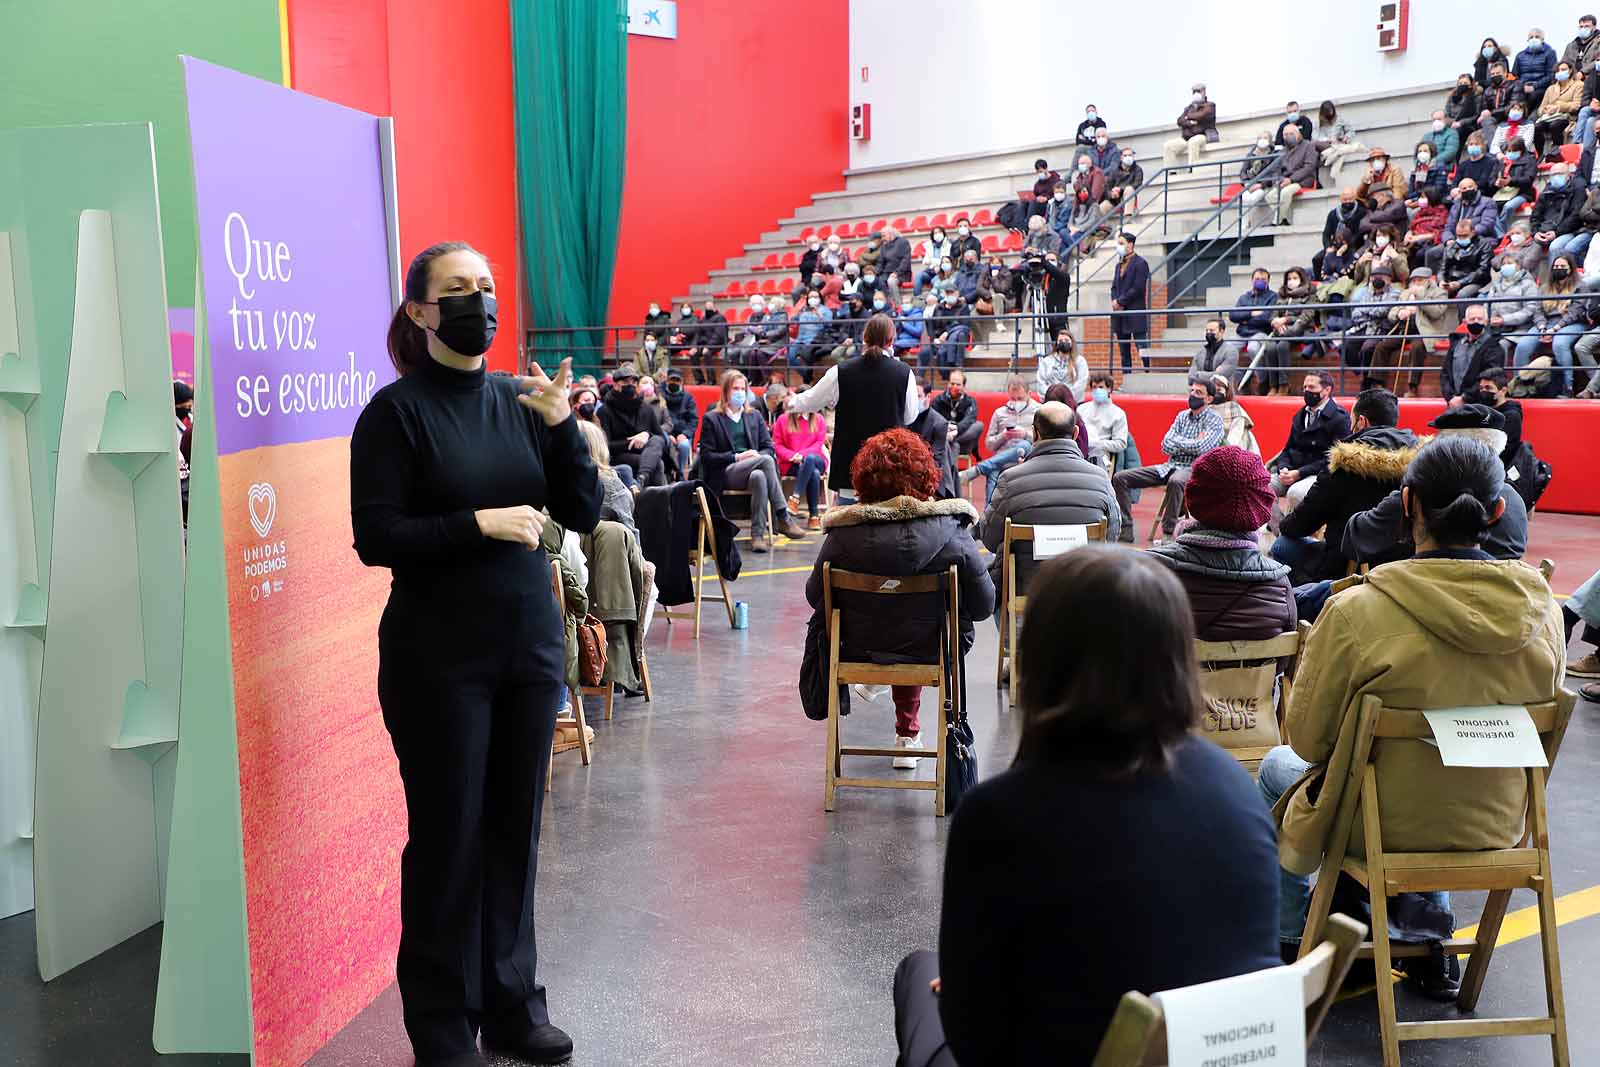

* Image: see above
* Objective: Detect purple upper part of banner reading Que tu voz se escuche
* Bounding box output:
[184,56,394,456]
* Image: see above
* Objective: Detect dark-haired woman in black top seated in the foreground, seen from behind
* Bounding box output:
[894,545,1278,1067]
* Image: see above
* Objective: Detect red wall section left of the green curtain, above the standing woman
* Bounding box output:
[290,0,522,370]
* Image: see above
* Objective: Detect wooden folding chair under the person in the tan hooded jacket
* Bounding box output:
[1301,689,1578,1067]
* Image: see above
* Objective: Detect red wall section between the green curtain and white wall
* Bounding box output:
[610,0,850,323]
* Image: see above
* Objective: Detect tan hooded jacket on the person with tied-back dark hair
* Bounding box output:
[1274,550,1566,873]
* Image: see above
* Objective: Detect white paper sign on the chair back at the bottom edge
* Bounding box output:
[1155,966,1306,1067]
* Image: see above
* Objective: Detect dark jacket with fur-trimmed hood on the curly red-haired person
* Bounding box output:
[805,496,995,664]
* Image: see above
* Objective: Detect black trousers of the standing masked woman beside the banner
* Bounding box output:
[378,588,565,1059]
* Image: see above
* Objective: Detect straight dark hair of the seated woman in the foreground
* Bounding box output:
[1016,545,1205,777]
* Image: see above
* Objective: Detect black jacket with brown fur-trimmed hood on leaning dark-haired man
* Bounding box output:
[1278,426,1419,581]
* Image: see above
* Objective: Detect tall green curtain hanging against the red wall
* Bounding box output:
[510,0,627,373]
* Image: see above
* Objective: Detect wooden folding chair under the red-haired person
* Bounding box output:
[822,563,962,817]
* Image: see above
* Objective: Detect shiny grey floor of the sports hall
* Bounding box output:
[0,498,1600,1067]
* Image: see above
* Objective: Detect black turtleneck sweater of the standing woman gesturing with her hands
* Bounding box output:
[350,360,600,604]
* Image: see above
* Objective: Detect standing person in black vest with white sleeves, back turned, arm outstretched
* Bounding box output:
[789,315,922,504]
